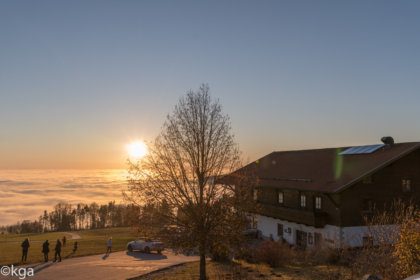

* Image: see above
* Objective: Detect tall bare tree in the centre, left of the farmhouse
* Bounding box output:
[126,85,253,279]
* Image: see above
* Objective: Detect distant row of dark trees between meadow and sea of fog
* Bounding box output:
[0,201,140,233]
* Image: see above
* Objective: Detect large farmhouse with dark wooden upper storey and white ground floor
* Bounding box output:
[241,137,420,247]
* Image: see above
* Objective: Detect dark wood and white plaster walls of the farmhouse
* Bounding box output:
[253,147,420,247]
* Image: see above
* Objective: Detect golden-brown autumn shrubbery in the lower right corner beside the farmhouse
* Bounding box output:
[345,200,420,280]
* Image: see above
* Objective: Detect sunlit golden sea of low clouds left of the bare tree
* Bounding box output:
[0,170,127,225]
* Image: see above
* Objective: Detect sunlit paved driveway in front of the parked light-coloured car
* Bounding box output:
[0,251,198,280]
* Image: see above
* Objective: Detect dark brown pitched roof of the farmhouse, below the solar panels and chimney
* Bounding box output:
[245,142,420,193]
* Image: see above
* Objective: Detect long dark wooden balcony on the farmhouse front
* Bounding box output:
[257,204,328,228]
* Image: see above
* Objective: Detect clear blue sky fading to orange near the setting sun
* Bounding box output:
[0,0,420,169]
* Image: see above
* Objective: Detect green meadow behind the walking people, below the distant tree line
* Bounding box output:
[0,228,137,265]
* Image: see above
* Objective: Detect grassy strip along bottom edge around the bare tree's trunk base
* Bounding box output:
[136,261,350,280]
